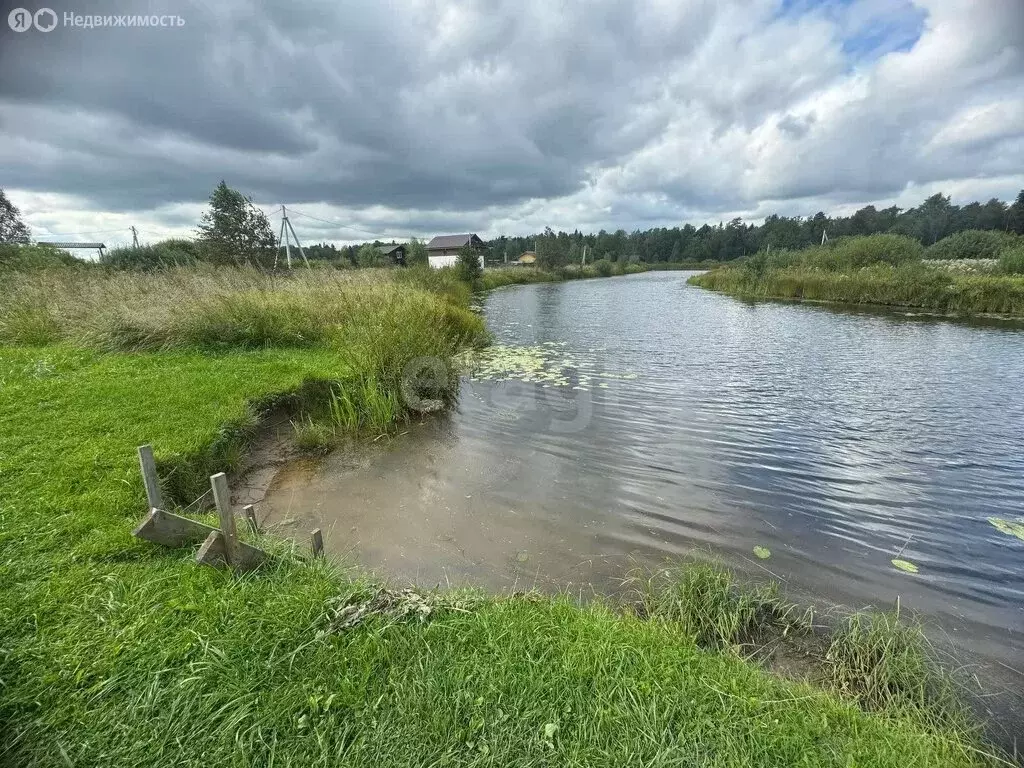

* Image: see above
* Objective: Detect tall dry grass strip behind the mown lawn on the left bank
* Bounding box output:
[0,265,482,351]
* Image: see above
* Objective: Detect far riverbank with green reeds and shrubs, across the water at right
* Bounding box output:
[689,233,1024,317]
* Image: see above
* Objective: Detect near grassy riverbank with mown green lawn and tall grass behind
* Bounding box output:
[0,264,1007,766]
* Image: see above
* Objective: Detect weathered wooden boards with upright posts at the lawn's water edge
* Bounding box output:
[132,445,268,570]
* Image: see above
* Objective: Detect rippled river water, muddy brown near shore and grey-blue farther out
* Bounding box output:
[261,272,1024,670]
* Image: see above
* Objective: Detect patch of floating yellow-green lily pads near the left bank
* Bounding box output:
[459,341,637,392]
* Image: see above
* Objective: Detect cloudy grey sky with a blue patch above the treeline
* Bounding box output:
[0,0,1024,243]
